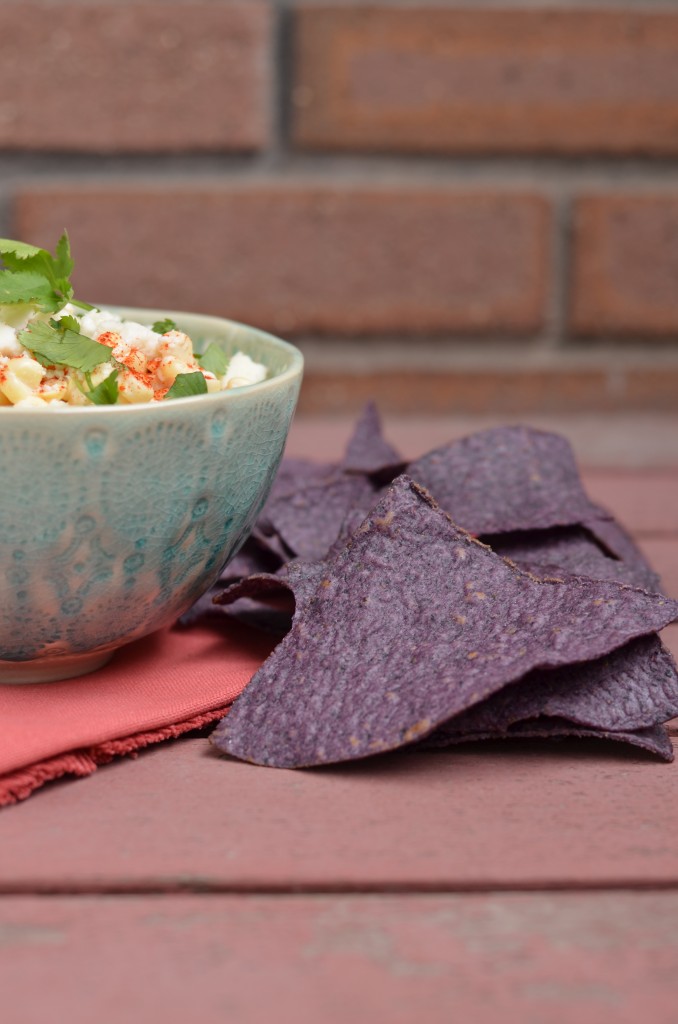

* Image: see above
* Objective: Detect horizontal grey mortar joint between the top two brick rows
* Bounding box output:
[5,153,678,186]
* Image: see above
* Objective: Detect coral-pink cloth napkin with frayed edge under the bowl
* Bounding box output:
[0,623,274,806]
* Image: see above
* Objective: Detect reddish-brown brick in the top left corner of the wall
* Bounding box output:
[0,0,270,153]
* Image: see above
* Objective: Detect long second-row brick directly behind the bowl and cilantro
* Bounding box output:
[13,183,549,334]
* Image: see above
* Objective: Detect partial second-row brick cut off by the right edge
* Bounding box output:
[571,193,678,338]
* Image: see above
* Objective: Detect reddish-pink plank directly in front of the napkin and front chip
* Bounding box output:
[0,739,678,892]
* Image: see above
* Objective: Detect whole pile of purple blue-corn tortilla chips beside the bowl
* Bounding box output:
[184,407,678,768]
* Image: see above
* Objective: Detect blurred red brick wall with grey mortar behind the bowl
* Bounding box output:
[0,0,678,413]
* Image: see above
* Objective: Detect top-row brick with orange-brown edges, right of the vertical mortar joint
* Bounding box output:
[292,5,678,154]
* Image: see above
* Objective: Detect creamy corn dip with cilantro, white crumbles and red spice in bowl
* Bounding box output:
[0,231,266,409]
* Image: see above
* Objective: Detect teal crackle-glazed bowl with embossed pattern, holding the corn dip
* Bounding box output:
[0,309,303,683]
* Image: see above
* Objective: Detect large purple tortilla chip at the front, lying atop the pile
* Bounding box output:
[211,476,678,767]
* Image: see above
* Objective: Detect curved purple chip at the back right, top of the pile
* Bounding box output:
[408,427,597,536]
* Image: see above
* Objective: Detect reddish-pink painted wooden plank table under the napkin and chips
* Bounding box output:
[0,424,678,1024]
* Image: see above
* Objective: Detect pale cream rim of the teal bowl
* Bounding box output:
[0,303,304,415]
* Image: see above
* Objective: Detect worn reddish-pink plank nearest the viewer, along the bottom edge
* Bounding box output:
[0,892,678,1024]
